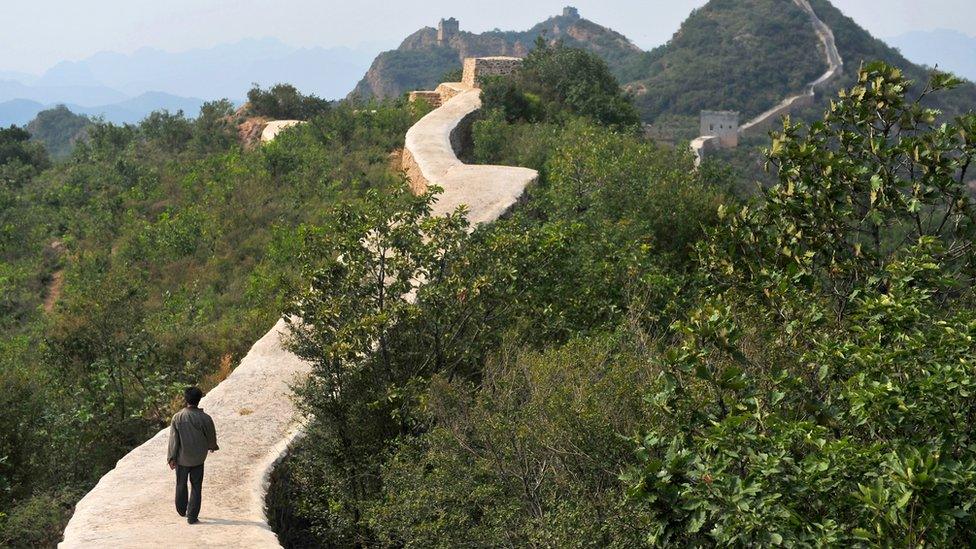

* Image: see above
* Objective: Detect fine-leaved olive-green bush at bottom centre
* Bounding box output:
[368,336,650,547]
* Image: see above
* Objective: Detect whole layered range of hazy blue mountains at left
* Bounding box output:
[0,38,382,126]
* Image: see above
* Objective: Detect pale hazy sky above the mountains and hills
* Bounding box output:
[0,0,976,73]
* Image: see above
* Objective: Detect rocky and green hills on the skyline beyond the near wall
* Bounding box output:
[353,0,976,138]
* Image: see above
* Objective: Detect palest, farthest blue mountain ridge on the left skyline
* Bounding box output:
[36,38,379,99]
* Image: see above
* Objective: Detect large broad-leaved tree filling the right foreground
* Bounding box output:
[623,64,976,547]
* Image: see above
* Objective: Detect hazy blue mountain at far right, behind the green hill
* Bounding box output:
[888,29,976,82]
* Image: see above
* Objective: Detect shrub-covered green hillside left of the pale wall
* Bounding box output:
[0,90,422,546]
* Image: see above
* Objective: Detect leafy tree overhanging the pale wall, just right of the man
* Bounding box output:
[285,184,466,544]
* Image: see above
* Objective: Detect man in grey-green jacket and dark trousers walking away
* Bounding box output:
[166,387,220,524]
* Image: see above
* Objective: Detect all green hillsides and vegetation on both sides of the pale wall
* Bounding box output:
[0,0,976,548]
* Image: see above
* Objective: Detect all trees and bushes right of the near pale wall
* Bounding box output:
[269,41,976,547]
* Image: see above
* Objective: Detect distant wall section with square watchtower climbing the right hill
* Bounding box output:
[691,0,844,164]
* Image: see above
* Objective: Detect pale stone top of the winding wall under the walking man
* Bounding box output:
[59,89,538,548]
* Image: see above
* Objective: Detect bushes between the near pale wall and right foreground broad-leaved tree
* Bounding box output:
[274,109,721,546]
